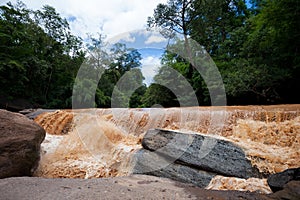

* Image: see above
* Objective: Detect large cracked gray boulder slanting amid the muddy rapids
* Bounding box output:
[132,129,263,187]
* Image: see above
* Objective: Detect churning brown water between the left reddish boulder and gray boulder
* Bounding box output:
[35,112,140,178]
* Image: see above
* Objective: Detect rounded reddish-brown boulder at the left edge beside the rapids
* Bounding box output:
[0,110,45,178]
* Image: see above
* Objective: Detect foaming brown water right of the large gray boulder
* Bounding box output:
[229,117,300,173]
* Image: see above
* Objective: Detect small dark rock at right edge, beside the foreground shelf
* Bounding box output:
[268,168,300,192]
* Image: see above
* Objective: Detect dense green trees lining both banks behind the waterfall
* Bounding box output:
[0,0,300,108]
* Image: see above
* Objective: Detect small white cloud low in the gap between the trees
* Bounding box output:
[141,56,161,85]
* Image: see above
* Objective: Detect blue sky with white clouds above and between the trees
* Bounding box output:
[0,0,167,85]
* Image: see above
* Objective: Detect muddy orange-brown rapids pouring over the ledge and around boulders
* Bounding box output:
[35,105,300,193]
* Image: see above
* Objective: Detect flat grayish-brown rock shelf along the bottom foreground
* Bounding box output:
[0,175,300,200]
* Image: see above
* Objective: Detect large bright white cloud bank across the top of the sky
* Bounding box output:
[0,0,167,38]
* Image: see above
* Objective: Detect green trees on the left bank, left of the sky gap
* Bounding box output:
[0,1,146,109]
